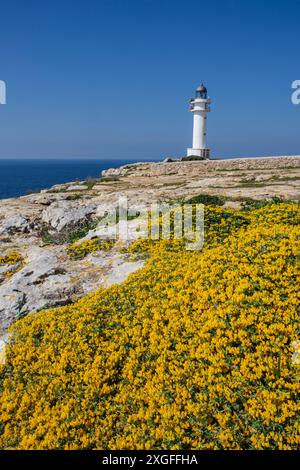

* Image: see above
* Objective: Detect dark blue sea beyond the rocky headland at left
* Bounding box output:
[0,160,139,199]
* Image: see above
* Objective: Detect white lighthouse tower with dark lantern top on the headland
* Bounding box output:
[187,83,211,158]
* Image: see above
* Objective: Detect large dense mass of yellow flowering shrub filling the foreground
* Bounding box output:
[0,203,300,449]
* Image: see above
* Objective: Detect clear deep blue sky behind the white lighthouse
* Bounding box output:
[0,0,300,160]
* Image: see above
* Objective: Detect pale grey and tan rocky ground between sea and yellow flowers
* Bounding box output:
[0,156,300,346]
